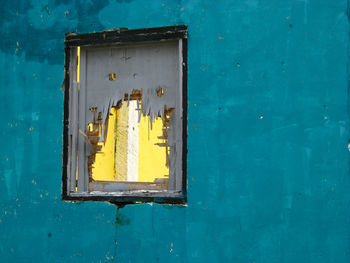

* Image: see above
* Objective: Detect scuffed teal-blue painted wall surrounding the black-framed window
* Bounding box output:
[0,0,350,263]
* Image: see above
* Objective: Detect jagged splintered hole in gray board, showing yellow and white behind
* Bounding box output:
[84,91,173,188]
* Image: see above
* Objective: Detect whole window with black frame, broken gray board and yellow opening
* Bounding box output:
[62,26,187,203]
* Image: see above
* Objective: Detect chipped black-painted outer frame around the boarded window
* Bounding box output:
[62,25,188,205]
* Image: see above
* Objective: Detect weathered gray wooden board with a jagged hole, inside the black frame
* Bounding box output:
[68,40,183,196]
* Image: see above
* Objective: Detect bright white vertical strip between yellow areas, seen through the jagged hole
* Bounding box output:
[127,100,139,182]
